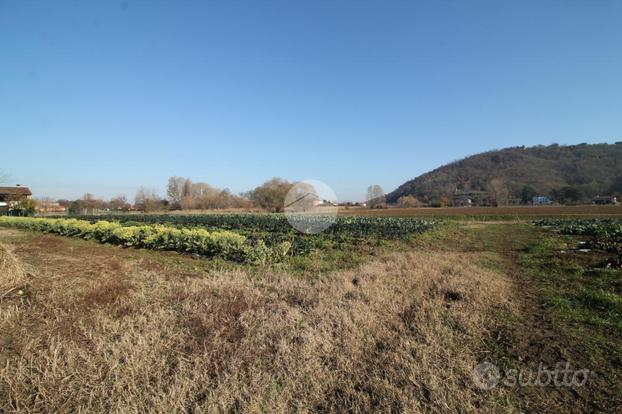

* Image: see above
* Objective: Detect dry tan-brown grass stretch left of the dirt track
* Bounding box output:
[0,230,512,413]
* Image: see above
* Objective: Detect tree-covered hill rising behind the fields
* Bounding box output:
[387,142,622,204]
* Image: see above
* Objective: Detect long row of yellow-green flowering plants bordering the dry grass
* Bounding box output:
[0,217,291,263]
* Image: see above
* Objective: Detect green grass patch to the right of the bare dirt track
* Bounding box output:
[518,234,622,367]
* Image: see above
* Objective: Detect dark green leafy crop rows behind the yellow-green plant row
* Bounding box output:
[57,214,436,239]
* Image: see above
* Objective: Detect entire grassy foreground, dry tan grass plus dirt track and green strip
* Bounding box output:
[0,223,622,413]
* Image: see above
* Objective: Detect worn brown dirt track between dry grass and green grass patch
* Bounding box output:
[445,222,621,412]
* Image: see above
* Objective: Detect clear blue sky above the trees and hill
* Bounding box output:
[0,0,622,200]
